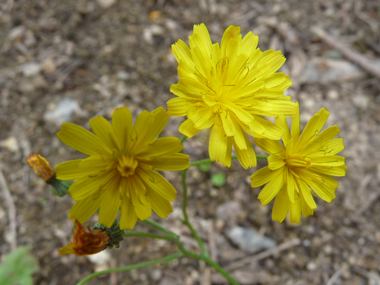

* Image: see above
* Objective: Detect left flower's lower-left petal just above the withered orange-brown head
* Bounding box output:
[69,195,103,224]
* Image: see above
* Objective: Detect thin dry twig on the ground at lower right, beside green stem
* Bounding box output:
[225,239,301,271]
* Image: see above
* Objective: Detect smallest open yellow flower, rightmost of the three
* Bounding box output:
[251,103,347,223]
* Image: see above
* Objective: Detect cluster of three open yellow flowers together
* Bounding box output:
[28,24,346,252]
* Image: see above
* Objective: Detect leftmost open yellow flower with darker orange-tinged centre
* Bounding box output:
[55,107,189,229]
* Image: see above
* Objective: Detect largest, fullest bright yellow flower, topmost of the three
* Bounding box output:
[167,24,296,168]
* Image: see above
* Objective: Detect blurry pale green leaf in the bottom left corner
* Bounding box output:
[0,246,38,285]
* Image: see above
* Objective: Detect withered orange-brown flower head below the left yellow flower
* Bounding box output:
[59,221,110,255]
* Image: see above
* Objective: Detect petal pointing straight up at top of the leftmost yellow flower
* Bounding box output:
[112,107,132,150]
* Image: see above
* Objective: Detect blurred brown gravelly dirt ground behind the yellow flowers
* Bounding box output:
[0,0,380,285]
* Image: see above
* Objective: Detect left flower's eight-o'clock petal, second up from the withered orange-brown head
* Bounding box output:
[69,170,115,201]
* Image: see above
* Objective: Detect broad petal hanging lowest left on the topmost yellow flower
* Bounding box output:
[208,121,227,162]
